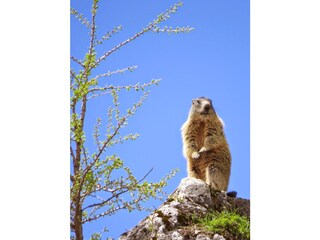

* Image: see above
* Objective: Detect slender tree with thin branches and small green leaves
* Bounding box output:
[70,0,192,240]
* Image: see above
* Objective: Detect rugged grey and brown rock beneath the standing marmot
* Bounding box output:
[120,178,250,240]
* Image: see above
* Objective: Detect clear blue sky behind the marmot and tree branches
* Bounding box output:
[71,0,250,239]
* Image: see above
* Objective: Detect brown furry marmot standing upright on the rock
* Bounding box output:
[181,97,231,192]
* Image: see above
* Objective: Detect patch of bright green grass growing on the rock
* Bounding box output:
[196,211,250,240]
